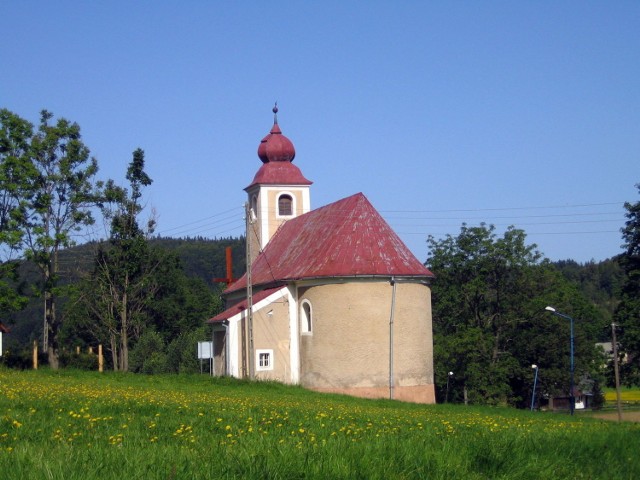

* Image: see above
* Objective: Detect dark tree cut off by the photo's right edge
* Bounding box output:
[614,184,640,385]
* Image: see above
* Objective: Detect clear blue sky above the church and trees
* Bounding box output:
[0,0,640,262]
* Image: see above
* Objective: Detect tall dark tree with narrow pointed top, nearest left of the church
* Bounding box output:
[69,149,156,371]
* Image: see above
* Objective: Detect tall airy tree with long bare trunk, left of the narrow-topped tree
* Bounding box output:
[17,110,99,369]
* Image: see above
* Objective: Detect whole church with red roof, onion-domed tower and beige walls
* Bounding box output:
[208,107,435,403]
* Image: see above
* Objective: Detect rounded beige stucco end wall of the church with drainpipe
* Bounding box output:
[298,281,434,403]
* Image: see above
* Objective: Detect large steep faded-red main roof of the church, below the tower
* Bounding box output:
[226,193,433,293]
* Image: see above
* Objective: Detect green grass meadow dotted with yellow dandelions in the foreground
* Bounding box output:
[0,369,640,480]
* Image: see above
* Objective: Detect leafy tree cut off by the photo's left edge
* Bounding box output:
[0,109,35,313]
